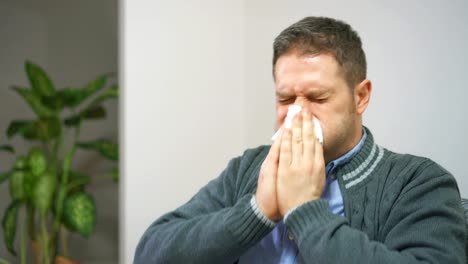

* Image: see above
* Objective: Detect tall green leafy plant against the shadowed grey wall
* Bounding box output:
[0,61,119,263]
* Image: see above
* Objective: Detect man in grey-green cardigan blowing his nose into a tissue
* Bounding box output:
[135,17,466,264]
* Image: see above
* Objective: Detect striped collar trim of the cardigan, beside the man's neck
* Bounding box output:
[338,127,385,189]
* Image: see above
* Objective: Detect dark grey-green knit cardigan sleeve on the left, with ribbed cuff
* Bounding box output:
[134,147,272,264]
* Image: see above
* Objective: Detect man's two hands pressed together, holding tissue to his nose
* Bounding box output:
[255,110,326,221]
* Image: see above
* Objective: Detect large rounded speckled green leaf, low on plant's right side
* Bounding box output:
[63,192,96,238]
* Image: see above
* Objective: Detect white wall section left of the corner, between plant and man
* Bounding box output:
[121,0,245,263]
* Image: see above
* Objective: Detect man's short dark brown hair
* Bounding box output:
[273,17,367,88]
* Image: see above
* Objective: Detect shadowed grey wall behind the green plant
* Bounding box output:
[0,0,118,263]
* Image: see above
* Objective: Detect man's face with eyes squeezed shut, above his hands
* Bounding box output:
[275,52,362,162]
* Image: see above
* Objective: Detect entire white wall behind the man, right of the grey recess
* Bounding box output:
[121,0,468,263]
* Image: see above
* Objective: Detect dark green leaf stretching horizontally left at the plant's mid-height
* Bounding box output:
[7,117,61,141]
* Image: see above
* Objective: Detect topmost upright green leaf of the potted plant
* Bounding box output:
[25,61,55,96]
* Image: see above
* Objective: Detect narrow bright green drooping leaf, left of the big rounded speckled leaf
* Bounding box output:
[32,172,57,217]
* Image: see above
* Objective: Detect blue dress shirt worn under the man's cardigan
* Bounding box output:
[239,130,367,264]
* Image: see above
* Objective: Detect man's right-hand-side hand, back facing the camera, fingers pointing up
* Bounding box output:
[276,110,326,216]
